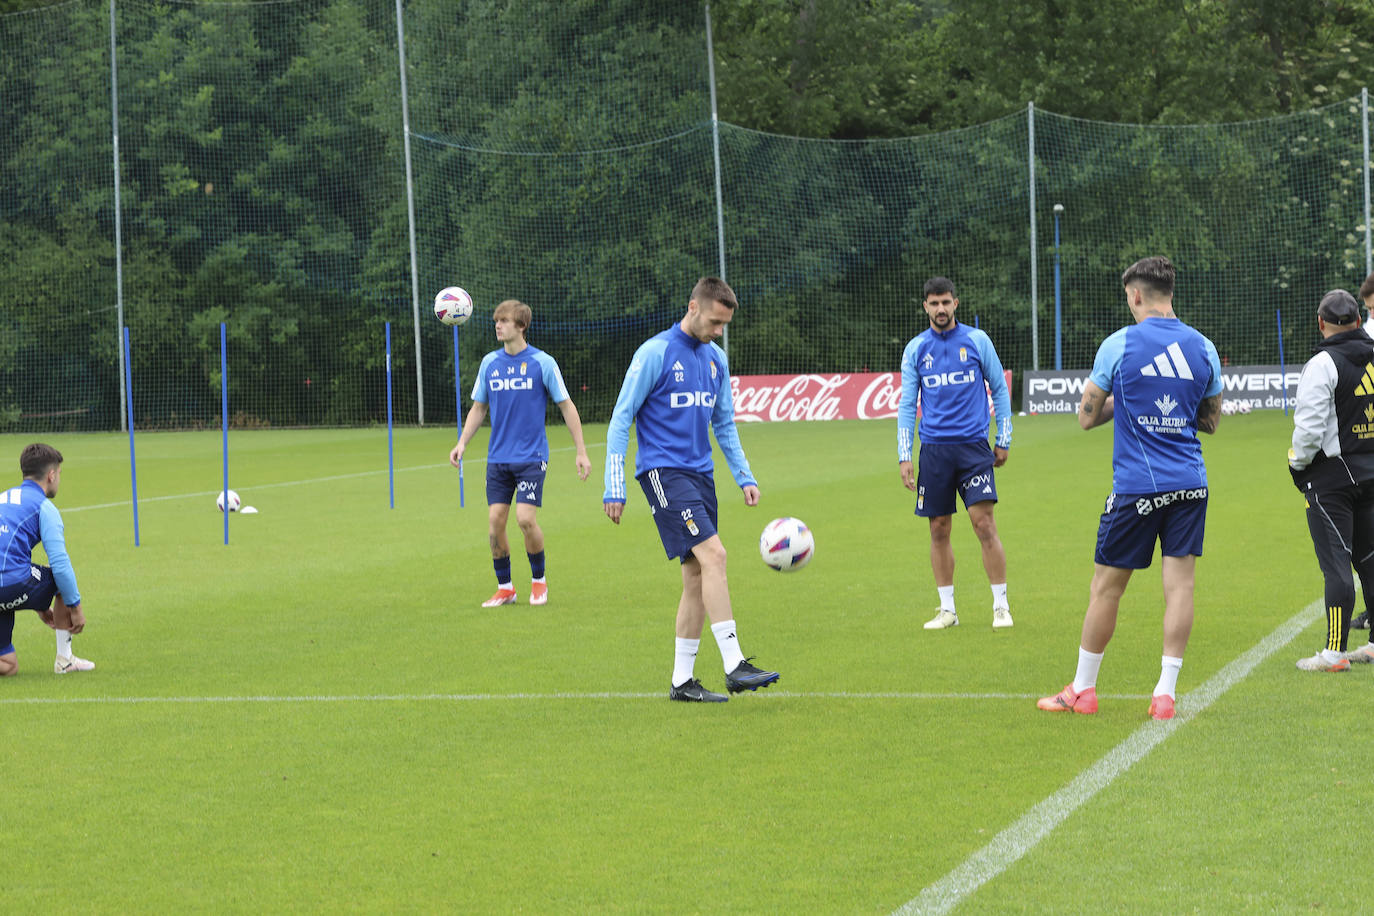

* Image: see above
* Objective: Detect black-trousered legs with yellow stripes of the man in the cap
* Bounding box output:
[1297,488,1356,672]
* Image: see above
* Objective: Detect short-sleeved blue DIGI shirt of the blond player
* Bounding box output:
[473,346,567,464]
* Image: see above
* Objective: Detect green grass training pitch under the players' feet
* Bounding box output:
[0,412,1357,913]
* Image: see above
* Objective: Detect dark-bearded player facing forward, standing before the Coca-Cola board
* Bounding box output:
[897,276,1011,630]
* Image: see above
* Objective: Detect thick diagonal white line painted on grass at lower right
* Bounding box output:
[893,600,1323,916]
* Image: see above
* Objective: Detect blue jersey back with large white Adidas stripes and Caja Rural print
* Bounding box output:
[1088,317,1221,494]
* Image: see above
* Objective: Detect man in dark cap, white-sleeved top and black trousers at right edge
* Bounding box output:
[1289,290,1374,672]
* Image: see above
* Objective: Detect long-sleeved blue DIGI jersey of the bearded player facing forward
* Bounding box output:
[897,321,1011,461]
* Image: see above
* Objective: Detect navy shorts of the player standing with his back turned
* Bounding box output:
[1092,486,1206,570]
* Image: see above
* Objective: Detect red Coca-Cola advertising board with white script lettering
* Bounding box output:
[730,372,1011,423]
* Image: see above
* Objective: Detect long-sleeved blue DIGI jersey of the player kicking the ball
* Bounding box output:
[602,324,757,503]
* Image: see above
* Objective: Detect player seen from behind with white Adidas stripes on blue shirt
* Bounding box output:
[1036,257,1221,718]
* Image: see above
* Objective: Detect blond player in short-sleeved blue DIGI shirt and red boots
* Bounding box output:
[448,299,592,607]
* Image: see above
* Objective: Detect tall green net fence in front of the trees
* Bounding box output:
[0,0,1369,431]
